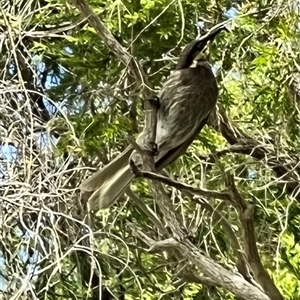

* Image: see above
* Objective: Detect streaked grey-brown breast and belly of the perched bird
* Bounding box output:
[156,68,217,161]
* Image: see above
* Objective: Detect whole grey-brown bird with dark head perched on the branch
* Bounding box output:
[80,25,227,211]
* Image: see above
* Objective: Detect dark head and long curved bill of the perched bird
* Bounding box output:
[176,25,228,70]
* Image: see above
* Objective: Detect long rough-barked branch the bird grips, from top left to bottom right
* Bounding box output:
[72,0,269,300]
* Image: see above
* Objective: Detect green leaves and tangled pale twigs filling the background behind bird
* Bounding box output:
[0,0,300,300]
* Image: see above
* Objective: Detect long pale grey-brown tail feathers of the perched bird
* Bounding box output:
[80,146,134,210]
